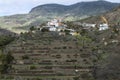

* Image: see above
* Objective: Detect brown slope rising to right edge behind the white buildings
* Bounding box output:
[80,7,120,26]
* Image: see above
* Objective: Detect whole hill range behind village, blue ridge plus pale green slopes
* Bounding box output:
[0,1,119,33]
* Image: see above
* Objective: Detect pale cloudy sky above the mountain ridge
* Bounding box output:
[0,0,120,16]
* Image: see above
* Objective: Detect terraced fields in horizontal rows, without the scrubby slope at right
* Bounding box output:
[2,31,93,80]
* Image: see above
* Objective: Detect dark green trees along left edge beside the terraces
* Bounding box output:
[0,35,15,74]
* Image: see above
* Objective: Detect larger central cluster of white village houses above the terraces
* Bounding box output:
[40,19,79,36]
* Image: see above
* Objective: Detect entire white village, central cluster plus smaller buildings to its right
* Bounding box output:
[37,17,109,36]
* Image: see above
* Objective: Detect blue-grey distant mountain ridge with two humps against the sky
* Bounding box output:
[30,1,119,16]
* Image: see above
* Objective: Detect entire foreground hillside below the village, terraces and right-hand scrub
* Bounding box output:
[0,27,120,80]
